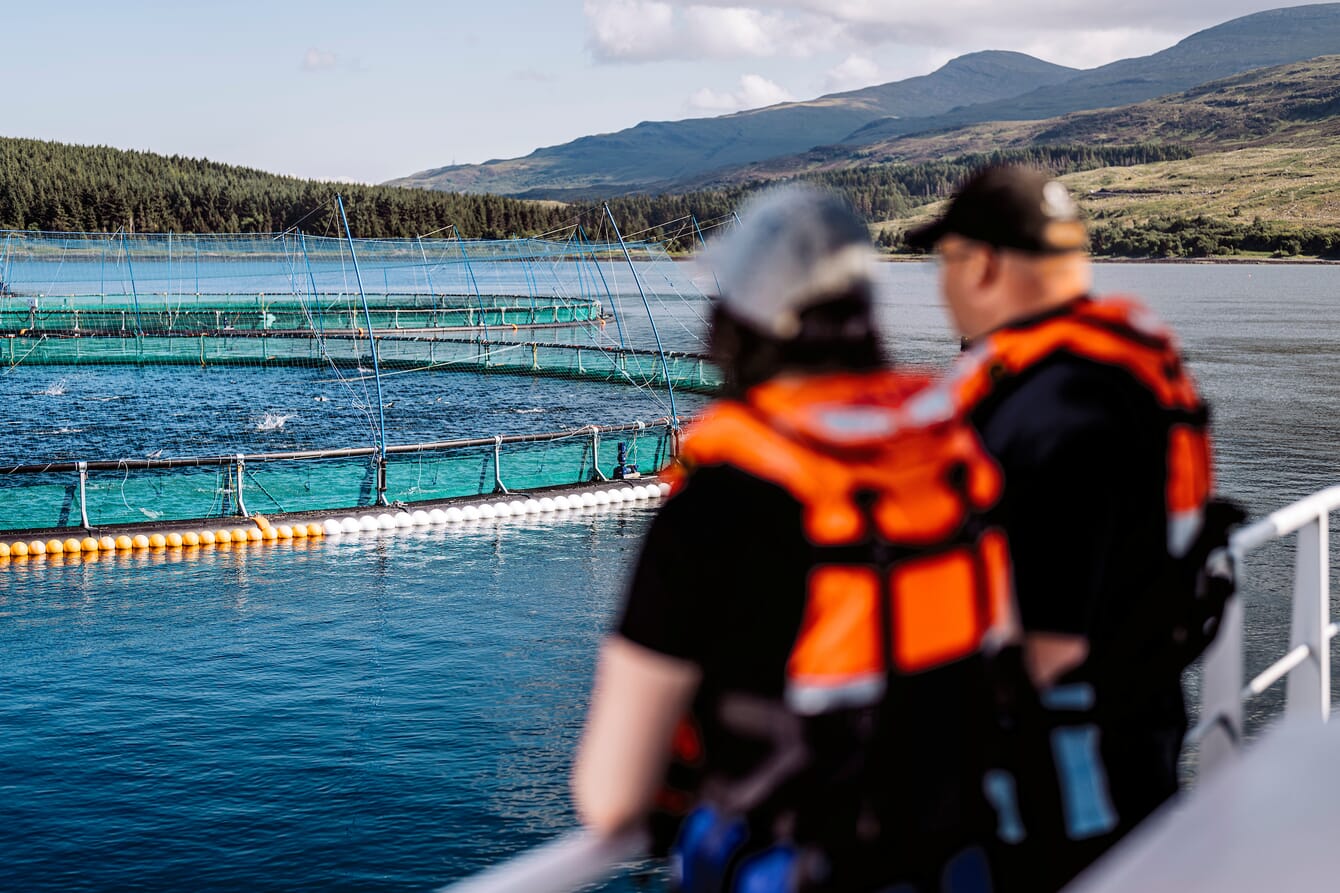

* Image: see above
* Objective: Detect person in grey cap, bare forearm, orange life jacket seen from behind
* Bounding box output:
[574,182,1013,893]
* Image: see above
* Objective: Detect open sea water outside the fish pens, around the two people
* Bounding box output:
[0,264,1340,890]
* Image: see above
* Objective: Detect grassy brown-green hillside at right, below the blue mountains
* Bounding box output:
[846,56,1340,246]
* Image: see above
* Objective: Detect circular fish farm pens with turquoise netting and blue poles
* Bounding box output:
[0,228,720,531]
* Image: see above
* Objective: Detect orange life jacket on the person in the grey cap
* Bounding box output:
[670,364,1013,715]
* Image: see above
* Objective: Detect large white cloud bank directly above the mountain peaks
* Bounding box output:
[583,0,1278,66]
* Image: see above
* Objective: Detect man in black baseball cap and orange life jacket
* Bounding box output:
[907,166,1241,890]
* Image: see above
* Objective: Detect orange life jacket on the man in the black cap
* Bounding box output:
[946,298,1213,558]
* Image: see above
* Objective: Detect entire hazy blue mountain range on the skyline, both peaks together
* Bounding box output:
[391,3,1340,198]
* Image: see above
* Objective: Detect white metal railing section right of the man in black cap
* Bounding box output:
[1187,485,1340,772]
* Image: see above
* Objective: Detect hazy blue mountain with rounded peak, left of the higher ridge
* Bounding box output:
[387,51,1076,196]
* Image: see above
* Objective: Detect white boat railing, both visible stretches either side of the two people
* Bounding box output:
[440,485,1340,893]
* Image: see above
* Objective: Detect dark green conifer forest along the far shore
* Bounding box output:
[0,138,1216,251]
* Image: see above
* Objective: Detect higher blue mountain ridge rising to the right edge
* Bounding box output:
[843,3,1340,145]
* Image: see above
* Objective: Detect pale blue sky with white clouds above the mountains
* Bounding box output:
[0,0,1313,182]
